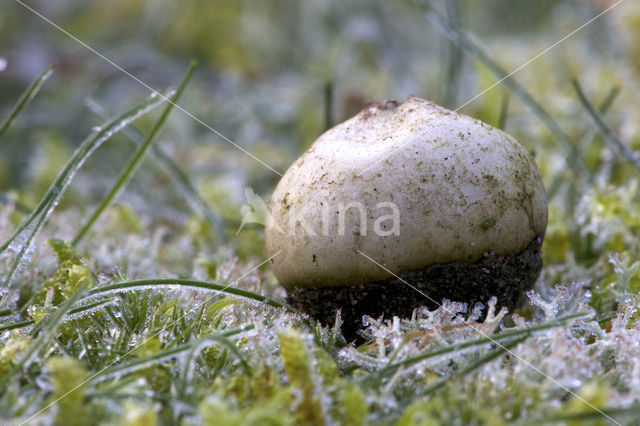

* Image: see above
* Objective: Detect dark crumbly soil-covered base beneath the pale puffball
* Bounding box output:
[287,237,542,341]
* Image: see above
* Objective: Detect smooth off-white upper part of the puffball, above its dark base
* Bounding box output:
[265,97,547,289]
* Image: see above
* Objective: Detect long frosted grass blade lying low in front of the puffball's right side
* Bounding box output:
[364,312,589,380]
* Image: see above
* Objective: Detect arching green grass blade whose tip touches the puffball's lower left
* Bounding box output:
[87,278,313,328]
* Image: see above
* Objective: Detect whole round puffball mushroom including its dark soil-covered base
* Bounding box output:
[265,97,547,331]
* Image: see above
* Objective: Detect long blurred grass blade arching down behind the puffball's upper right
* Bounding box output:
[426,10,590,178]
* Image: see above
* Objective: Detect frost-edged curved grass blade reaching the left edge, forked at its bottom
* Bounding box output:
[0,90,171,287]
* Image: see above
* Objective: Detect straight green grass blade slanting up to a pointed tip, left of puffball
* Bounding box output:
[72,61,196,246]
